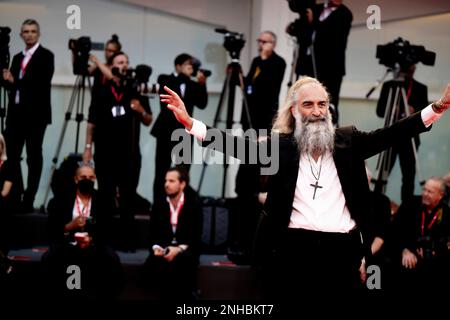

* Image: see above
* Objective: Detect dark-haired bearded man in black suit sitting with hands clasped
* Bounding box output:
[143,167,202,298]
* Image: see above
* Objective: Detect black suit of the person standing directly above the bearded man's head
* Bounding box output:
[297,3,353,123]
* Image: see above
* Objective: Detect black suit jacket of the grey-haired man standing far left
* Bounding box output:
[5,45,55,126]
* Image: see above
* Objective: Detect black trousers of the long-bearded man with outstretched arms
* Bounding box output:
[266,228,363,300]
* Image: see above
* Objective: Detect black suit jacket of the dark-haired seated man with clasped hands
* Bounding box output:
[150,188,203,255]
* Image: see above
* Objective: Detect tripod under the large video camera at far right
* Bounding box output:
[368,74,423,193]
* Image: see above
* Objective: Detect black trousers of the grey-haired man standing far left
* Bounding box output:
[5,121,47,207]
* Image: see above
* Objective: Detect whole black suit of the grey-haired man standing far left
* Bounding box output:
[5,45,55,207]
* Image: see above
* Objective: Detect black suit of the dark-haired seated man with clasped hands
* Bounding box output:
[144,188,203,297]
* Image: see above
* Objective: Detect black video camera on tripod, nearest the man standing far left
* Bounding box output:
[69,36,105,75]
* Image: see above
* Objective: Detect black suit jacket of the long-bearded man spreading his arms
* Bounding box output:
[203,113,429,254]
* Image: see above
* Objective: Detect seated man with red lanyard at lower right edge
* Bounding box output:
[394,177,450,288]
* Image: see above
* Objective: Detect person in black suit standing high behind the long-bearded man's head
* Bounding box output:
[288,0,353,125]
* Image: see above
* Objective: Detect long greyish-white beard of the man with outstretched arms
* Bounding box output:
[294,109,334,155]
